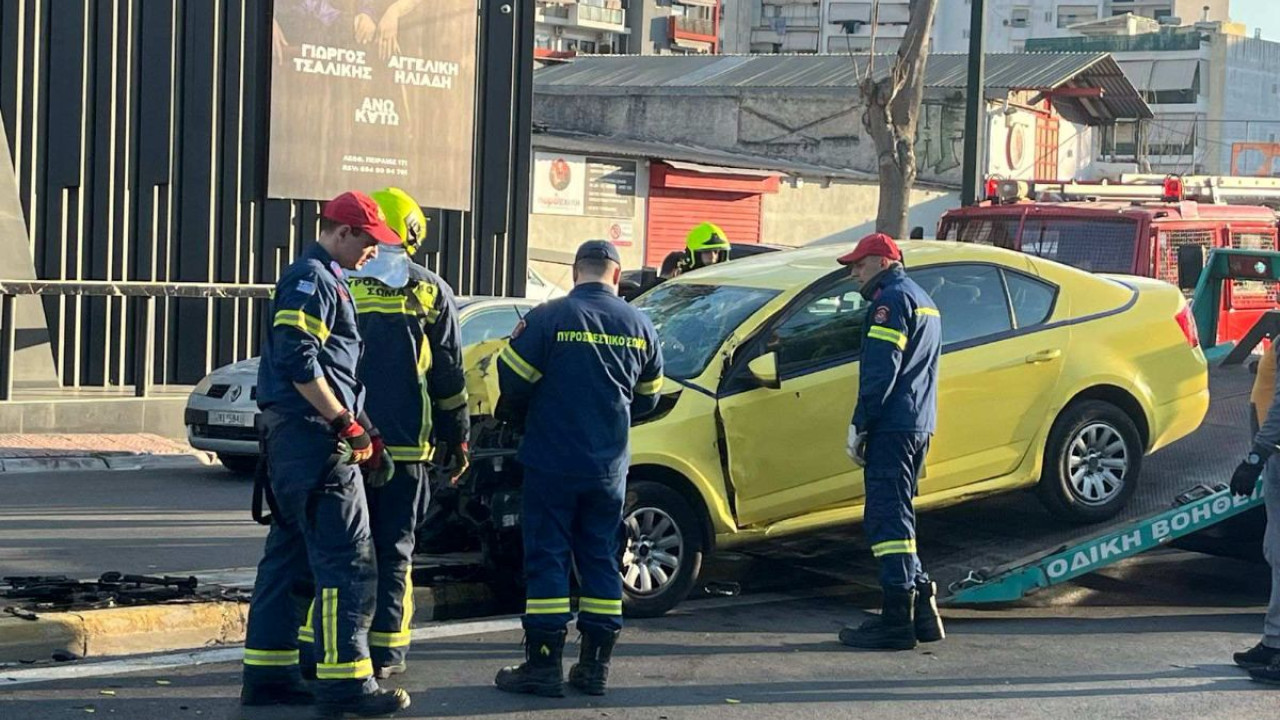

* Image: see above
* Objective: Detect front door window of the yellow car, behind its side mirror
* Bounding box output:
[767,277,867,377]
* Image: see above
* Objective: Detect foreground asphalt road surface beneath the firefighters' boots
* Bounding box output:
[0,589,1280,720]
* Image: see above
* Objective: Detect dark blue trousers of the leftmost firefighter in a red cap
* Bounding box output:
[244,413,378,700]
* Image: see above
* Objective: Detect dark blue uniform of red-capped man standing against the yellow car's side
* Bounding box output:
[852,265,942,591]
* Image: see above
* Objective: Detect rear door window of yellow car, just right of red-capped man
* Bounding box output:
[910,265,1014,345]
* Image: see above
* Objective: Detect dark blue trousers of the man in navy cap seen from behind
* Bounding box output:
[521,468,626,633]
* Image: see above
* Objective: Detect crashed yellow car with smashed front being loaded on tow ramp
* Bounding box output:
[458,241,1208,615]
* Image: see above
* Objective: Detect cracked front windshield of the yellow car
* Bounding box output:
[635,283,778,380]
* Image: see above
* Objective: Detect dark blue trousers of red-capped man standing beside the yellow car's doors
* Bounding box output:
[863,432,929,591]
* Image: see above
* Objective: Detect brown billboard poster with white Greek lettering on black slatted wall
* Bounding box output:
[268,0,476,210]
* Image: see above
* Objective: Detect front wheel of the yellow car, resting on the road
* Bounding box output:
[621,482,704,618]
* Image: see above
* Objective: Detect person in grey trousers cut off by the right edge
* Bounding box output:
[1231,345,1280,685]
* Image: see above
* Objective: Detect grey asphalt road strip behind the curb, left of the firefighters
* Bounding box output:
[0,465,266,579]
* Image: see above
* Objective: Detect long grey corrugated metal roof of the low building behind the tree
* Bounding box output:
[534,53,1152,118]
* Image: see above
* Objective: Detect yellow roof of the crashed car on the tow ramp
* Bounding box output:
[668,240,1028,291]
